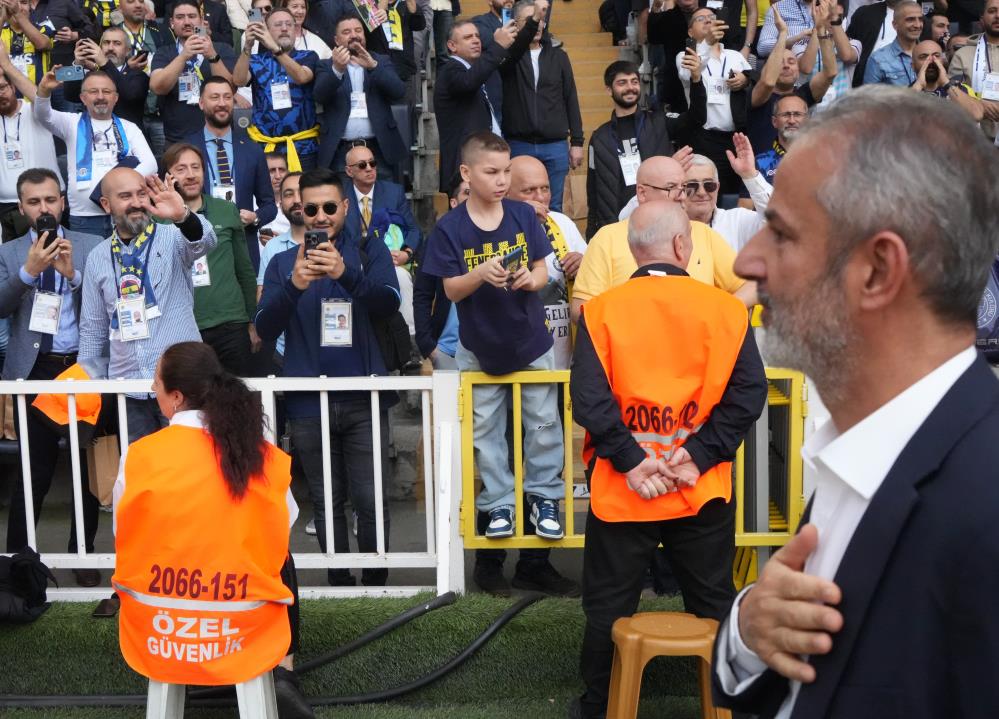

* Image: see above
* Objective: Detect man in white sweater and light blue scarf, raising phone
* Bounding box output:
[31,62,156,237]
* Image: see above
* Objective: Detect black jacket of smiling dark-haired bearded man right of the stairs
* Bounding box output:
[586,82,707,239]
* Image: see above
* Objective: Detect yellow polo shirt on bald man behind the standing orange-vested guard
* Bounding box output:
[572,220,746,302]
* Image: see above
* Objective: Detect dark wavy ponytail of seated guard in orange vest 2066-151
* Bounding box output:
[160,342,266,499]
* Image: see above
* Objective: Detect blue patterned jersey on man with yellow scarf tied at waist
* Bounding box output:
[250,50,319,155]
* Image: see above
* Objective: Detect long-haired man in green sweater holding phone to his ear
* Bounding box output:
[163,142,260,377]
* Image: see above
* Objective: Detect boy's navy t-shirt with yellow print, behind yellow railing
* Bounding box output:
[422,200,552,375]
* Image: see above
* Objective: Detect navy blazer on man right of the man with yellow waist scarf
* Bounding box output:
[313,53,408,171]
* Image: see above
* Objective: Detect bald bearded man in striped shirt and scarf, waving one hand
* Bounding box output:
[78,167,218,442]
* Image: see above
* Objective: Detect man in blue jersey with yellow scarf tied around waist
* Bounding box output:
[232,9,319,170]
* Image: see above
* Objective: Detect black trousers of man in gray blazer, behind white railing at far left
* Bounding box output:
[7,355,100,552]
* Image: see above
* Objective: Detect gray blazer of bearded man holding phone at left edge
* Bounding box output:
[0,227,104,380]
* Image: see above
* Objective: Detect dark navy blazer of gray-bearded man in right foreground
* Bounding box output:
[712,357,999,719]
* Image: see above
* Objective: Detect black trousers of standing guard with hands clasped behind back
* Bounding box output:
[579,498,735,717]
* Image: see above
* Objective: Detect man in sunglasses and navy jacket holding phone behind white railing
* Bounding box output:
[254,168,399,586]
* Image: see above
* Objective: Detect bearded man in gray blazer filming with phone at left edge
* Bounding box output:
[0,168,101,587]
